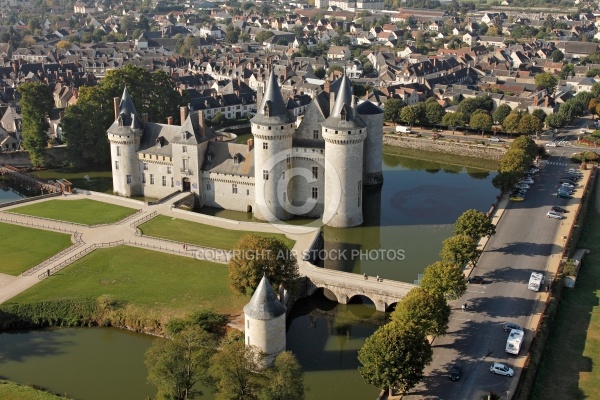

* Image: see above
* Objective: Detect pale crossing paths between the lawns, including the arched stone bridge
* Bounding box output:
[0,191,414,309]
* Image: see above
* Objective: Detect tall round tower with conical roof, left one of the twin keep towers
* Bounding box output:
[250,70,295,221]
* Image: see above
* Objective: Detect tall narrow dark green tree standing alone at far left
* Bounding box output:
[18,82,54,167]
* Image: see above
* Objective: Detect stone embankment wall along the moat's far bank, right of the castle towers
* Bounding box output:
[383,135,506,161]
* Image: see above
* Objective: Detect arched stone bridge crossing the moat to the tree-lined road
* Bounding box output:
[299,261,415,312]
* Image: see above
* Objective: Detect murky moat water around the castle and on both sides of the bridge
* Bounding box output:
[0,156,498,400]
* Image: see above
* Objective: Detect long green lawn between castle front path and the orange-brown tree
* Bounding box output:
[139,215,295,250]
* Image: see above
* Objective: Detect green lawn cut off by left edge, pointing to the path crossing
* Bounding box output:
[0,223,71,276]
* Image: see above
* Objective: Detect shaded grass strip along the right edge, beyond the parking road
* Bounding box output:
[530,195,600,400]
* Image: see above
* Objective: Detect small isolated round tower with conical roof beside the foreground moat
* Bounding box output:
[244,276,286,367]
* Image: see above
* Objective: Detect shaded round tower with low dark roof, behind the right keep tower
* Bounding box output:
[356,101,383,185]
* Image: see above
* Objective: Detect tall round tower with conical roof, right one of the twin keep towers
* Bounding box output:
[321,75,367,228]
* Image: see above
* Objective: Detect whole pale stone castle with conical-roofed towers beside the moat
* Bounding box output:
[108,71,383,227]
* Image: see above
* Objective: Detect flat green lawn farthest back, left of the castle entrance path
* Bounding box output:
[10,199,137,225]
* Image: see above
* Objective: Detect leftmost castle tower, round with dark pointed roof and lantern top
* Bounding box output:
[107,88,143,197]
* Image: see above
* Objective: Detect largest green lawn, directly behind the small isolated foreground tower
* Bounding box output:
[6,246,248,317]
